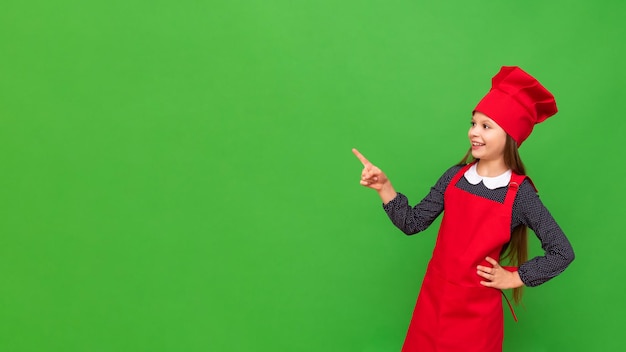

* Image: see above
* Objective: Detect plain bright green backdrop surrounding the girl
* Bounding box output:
[0,0,626,352]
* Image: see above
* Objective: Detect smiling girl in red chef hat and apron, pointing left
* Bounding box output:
[353,66,574,352]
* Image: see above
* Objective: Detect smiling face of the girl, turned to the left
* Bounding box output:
[468,111,506,161]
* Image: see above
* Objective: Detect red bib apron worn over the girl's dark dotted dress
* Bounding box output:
[402,165,526,352]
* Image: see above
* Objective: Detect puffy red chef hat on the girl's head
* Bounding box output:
[474,66,557,147]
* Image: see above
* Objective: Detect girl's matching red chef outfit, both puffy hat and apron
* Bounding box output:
[402,67,557,352]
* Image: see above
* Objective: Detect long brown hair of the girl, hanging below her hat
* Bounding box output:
[459,134,528,304]
